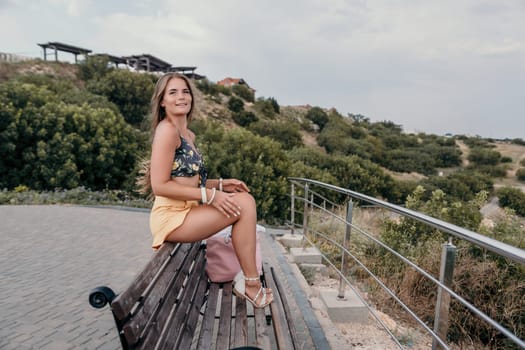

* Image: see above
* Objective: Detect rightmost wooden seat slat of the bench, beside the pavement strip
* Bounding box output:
[263,263,295,349]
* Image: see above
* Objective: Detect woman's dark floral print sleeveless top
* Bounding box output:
[171,136,208,186]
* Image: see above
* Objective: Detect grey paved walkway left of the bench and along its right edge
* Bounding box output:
[0,206,328,350]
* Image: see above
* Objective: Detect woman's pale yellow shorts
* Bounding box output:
[149,196,199,249]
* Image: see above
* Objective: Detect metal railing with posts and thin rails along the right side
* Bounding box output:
[288,178,525,349]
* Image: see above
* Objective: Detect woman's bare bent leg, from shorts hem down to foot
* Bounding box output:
[166,192,270,302]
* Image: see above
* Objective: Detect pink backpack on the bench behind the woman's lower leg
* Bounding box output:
[206,225,266,282]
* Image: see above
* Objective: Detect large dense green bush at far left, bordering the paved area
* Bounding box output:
[0,81,139,190]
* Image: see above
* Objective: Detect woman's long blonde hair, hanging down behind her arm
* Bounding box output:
[136,73,195,199]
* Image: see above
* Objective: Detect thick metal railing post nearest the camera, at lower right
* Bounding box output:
[432,238,456,350]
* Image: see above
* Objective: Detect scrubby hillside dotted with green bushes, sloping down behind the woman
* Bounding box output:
[0,60,525,211]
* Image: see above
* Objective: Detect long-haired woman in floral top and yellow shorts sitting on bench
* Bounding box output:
[141,73,273,308]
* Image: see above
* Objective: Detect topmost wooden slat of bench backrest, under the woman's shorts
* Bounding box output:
[111,243,189,321]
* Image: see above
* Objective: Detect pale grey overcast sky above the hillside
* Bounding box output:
[0,0,525,139]
